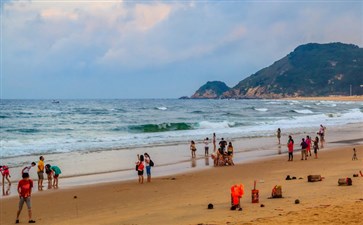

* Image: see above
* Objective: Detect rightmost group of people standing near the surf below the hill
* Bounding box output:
[284,125,326,161]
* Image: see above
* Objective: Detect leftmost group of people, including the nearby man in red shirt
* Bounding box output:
[0,156,62,223]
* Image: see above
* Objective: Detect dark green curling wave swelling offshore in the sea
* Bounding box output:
[128,123,194,133]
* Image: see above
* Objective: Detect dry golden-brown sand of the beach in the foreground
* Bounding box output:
[0,145,363,225]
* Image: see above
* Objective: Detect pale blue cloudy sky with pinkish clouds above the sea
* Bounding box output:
[0,0,363,99]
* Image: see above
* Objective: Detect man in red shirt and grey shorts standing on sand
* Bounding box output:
[15,173,35,223]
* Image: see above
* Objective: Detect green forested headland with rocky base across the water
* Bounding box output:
[191,43,363,99]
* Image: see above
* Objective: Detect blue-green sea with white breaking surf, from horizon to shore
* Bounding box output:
[0,99,363,163]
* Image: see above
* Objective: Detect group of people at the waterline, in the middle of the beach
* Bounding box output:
[190,133,234,166]
